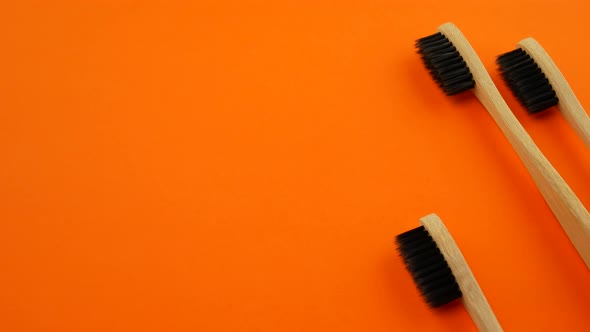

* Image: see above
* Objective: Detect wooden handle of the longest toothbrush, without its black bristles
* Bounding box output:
[439,23,590,268]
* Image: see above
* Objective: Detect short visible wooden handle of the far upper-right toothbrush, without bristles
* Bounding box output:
[518,38,590,148]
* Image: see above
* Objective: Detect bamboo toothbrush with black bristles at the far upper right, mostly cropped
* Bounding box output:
[496,38,590,148]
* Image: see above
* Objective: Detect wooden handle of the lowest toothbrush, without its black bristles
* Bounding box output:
[420,213,503,332]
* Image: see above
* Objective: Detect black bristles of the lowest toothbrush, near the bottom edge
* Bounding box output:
[395,226,462,308]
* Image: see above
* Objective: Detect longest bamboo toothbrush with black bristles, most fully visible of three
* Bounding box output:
[416,23,590,268]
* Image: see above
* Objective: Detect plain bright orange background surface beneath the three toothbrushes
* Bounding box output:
[0,0,590,332]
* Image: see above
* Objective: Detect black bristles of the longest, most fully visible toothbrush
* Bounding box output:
[416,32,475,96]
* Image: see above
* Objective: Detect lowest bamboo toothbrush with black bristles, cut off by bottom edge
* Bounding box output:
[395,214,502,332]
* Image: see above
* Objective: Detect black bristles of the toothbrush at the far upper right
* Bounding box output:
[496,48,559,113]
